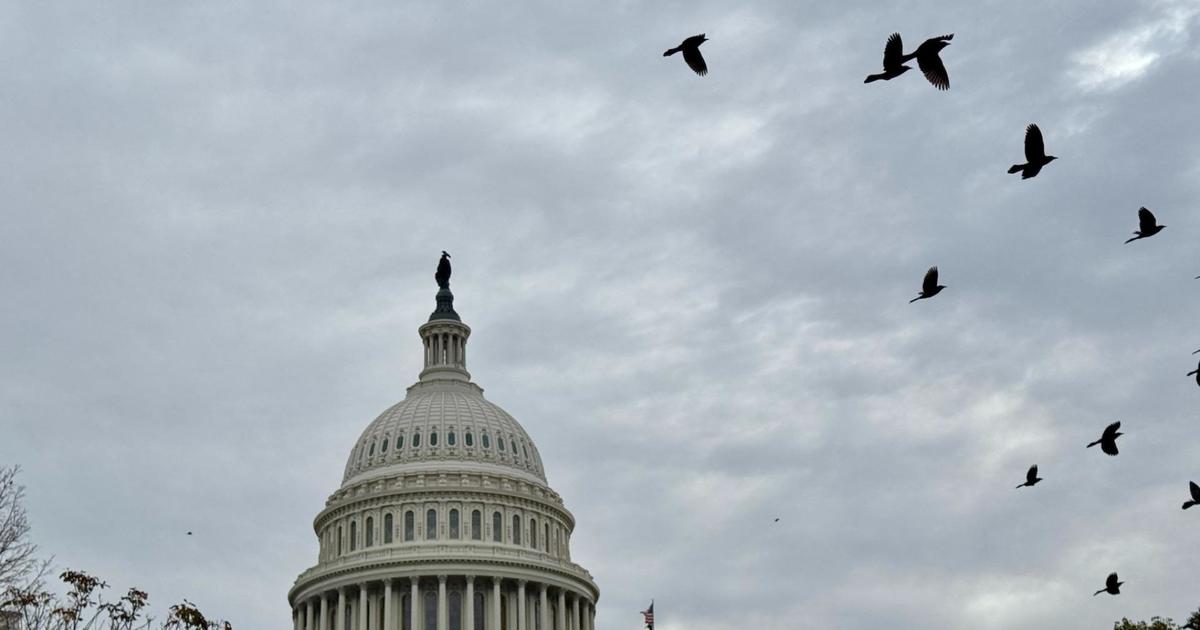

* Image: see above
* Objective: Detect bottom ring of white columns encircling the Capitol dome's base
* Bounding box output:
[292,575,595,630]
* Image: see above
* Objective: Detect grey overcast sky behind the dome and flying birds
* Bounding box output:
[0,0,1200,630]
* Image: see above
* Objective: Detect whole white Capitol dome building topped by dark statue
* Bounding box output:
[288,276,600,630]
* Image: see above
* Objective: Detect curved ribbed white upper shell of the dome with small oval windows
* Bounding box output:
[342,380,546,487]
